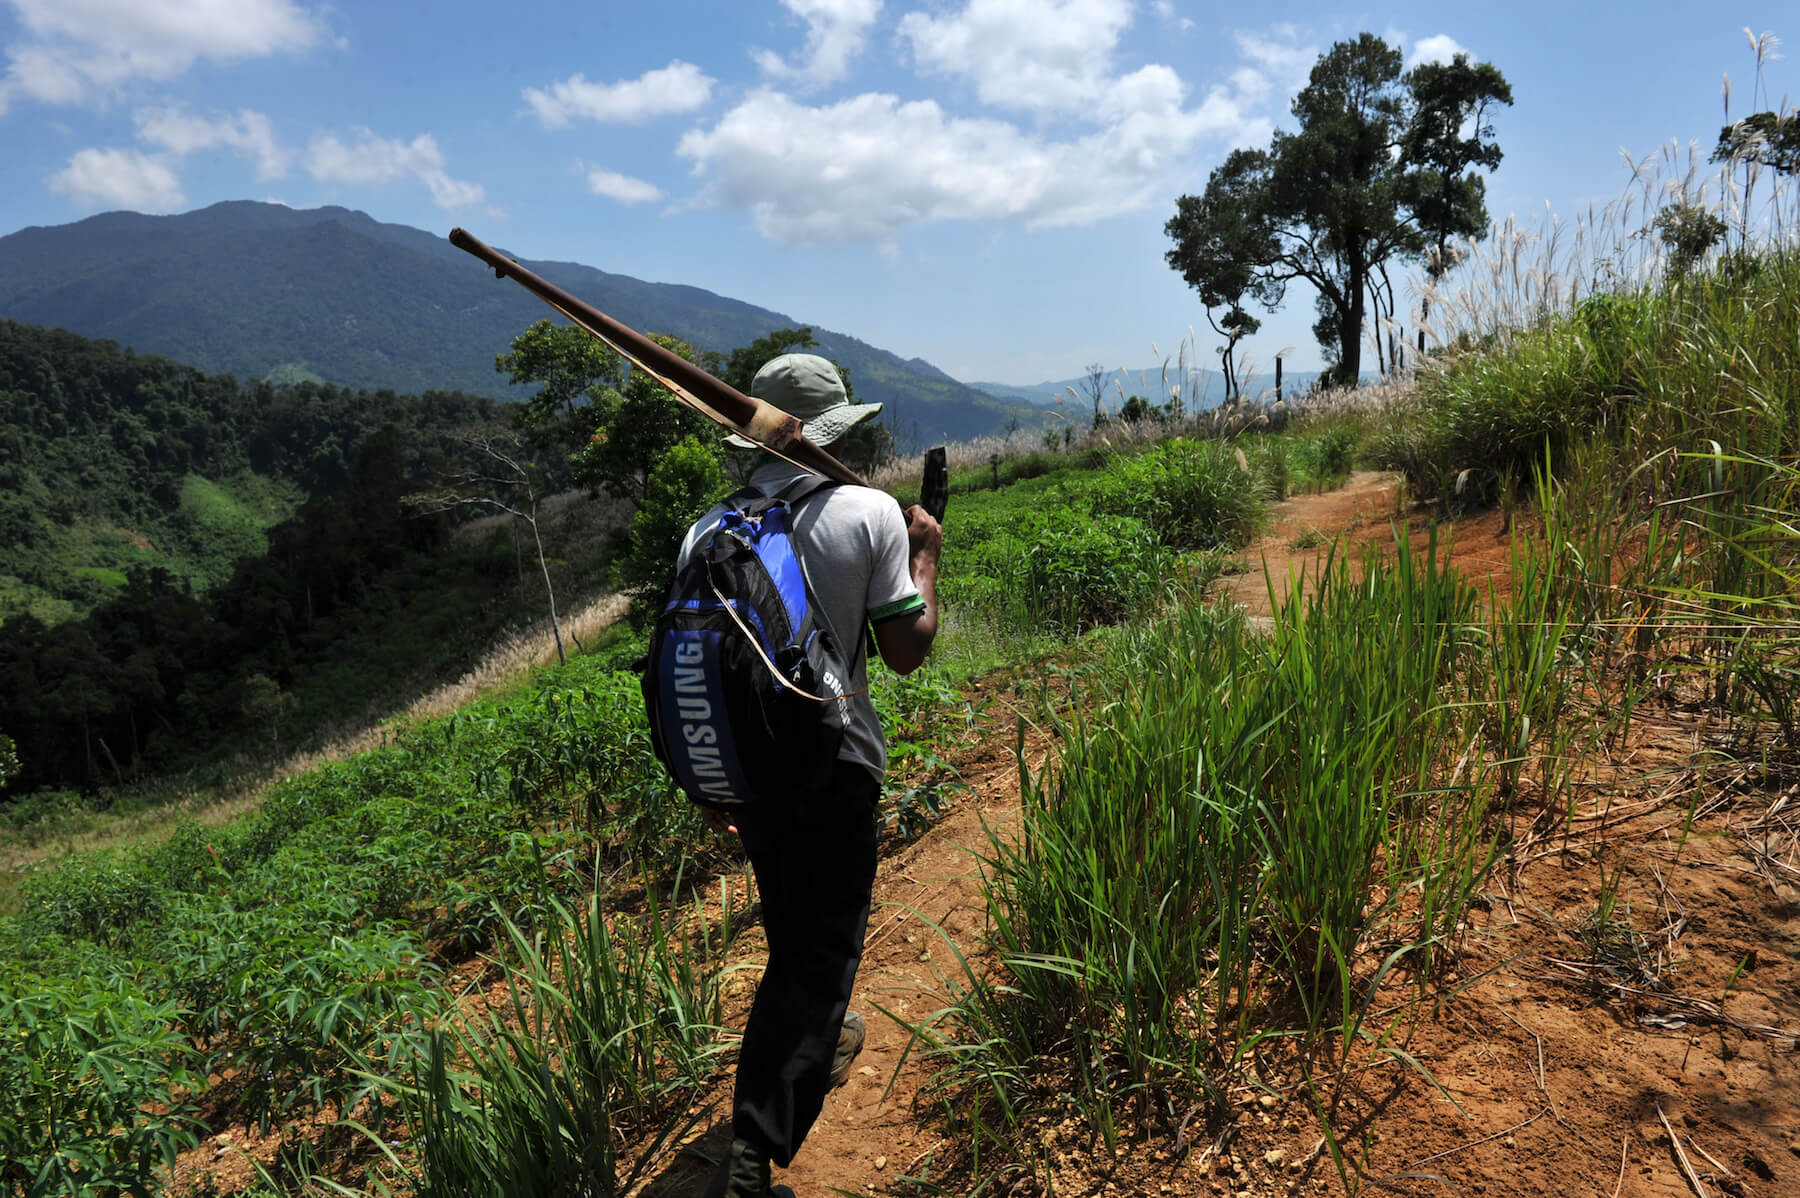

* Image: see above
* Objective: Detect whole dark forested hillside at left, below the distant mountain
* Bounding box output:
[0,322,565,793]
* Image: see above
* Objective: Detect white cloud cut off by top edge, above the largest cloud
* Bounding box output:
[900,0,1132,112]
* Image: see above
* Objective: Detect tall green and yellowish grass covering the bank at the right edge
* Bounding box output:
[1375,229,1800,766]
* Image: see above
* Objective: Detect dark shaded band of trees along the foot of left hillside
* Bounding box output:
[0,395,614,791]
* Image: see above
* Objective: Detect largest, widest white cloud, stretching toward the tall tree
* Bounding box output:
[677,83,1267,243]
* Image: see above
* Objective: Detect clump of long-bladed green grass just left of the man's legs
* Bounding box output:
[371,877,731,1198]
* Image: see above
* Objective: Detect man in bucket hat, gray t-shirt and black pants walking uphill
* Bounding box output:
[680,354,943,1198]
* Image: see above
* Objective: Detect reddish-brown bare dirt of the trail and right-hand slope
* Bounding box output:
[643,473,1800,1198]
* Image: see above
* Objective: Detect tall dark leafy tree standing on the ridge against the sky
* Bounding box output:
[1165,32,1512,385]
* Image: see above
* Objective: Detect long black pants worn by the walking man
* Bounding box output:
[731,761,880,1167]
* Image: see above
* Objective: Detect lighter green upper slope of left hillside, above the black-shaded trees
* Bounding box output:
[0,320,493,621]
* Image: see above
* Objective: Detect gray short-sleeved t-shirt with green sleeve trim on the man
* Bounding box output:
[675,460,925,781]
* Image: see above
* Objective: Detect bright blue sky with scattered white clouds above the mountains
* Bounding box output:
[0,0,1795,383]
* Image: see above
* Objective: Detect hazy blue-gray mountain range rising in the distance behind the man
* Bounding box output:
[0,200,1042,448]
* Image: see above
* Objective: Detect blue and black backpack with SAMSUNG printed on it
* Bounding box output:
[643,475,860,808]
